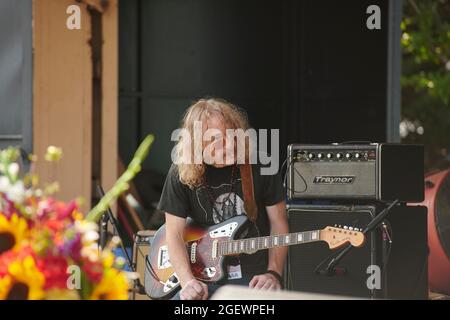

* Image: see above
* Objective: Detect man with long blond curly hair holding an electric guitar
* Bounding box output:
[158,99,288,300]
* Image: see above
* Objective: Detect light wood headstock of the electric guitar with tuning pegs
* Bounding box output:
[320,226,365,249]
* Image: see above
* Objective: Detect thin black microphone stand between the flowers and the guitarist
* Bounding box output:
[97,184,146,294]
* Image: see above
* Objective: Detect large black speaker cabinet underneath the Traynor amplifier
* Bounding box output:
[286,205,428,299]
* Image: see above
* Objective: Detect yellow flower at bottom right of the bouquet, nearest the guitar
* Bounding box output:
[90,268,128,300]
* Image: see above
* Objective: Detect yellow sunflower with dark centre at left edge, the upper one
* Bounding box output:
[0,213,28,254]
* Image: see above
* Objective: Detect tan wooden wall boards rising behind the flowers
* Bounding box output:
[33,0,117,210]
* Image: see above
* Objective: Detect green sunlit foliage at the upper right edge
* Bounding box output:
[401,0,450,167]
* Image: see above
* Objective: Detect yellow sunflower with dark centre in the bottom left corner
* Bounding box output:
[0,256,45,300]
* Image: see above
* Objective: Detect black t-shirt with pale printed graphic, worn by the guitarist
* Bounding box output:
[158,164,284,275]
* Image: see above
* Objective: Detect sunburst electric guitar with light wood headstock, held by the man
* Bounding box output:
[145,215,364,299]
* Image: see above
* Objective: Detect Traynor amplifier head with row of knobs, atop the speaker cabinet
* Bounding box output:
[287,143,424,202]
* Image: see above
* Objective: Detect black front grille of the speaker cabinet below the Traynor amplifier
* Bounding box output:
[288,206,379,297]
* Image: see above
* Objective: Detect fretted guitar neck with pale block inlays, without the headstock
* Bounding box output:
[218,230,320,256]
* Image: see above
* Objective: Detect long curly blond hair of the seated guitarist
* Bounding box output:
[175,98,249,188]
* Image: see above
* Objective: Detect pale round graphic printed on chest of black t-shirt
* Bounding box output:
[196,179,245,223]
